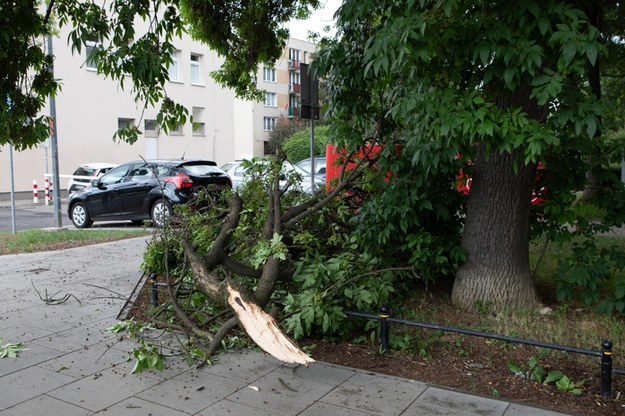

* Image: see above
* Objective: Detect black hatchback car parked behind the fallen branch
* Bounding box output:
[67,160,232,228]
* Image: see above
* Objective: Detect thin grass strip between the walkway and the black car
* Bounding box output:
[0,229,150,255]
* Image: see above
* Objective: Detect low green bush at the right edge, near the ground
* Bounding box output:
[554,239,625,314]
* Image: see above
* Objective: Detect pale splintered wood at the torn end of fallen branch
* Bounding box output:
[227,286,315,366]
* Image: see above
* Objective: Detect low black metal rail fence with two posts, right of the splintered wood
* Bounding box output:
[344,306,625,397]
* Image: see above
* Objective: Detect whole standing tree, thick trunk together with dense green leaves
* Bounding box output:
[316,0,623,307]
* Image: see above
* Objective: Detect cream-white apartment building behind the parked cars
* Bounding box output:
[0,25,315,193]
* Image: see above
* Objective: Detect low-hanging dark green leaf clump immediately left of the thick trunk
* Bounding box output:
[353,159,464,283]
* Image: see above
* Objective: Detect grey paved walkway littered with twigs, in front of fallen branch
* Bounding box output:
[0,237,576,416]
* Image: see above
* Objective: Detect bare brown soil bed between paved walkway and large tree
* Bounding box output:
[128,280,625,416]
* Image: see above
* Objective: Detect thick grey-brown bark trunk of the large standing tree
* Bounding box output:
[452,145,539,309]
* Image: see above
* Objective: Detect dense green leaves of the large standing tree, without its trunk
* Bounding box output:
[313,0,625,310]
